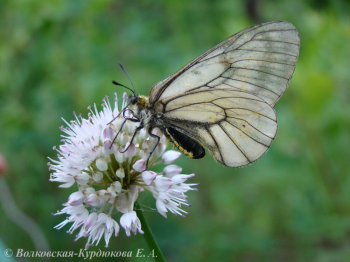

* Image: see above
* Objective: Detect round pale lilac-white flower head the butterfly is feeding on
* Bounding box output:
[49,93,197,249]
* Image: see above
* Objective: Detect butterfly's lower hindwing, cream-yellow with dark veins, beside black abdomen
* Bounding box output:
[155,88,277,167]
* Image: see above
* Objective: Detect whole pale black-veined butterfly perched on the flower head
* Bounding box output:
[115,22,299,170]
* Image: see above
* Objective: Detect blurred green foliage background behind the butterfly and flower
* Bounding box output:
[0,0,350,262]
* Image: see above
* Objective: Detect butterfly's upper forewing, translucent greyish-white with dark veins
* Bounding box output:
[149,22,299,107]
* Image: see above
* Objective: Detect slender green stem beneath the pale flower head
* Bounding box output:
[135,201,166,262]
